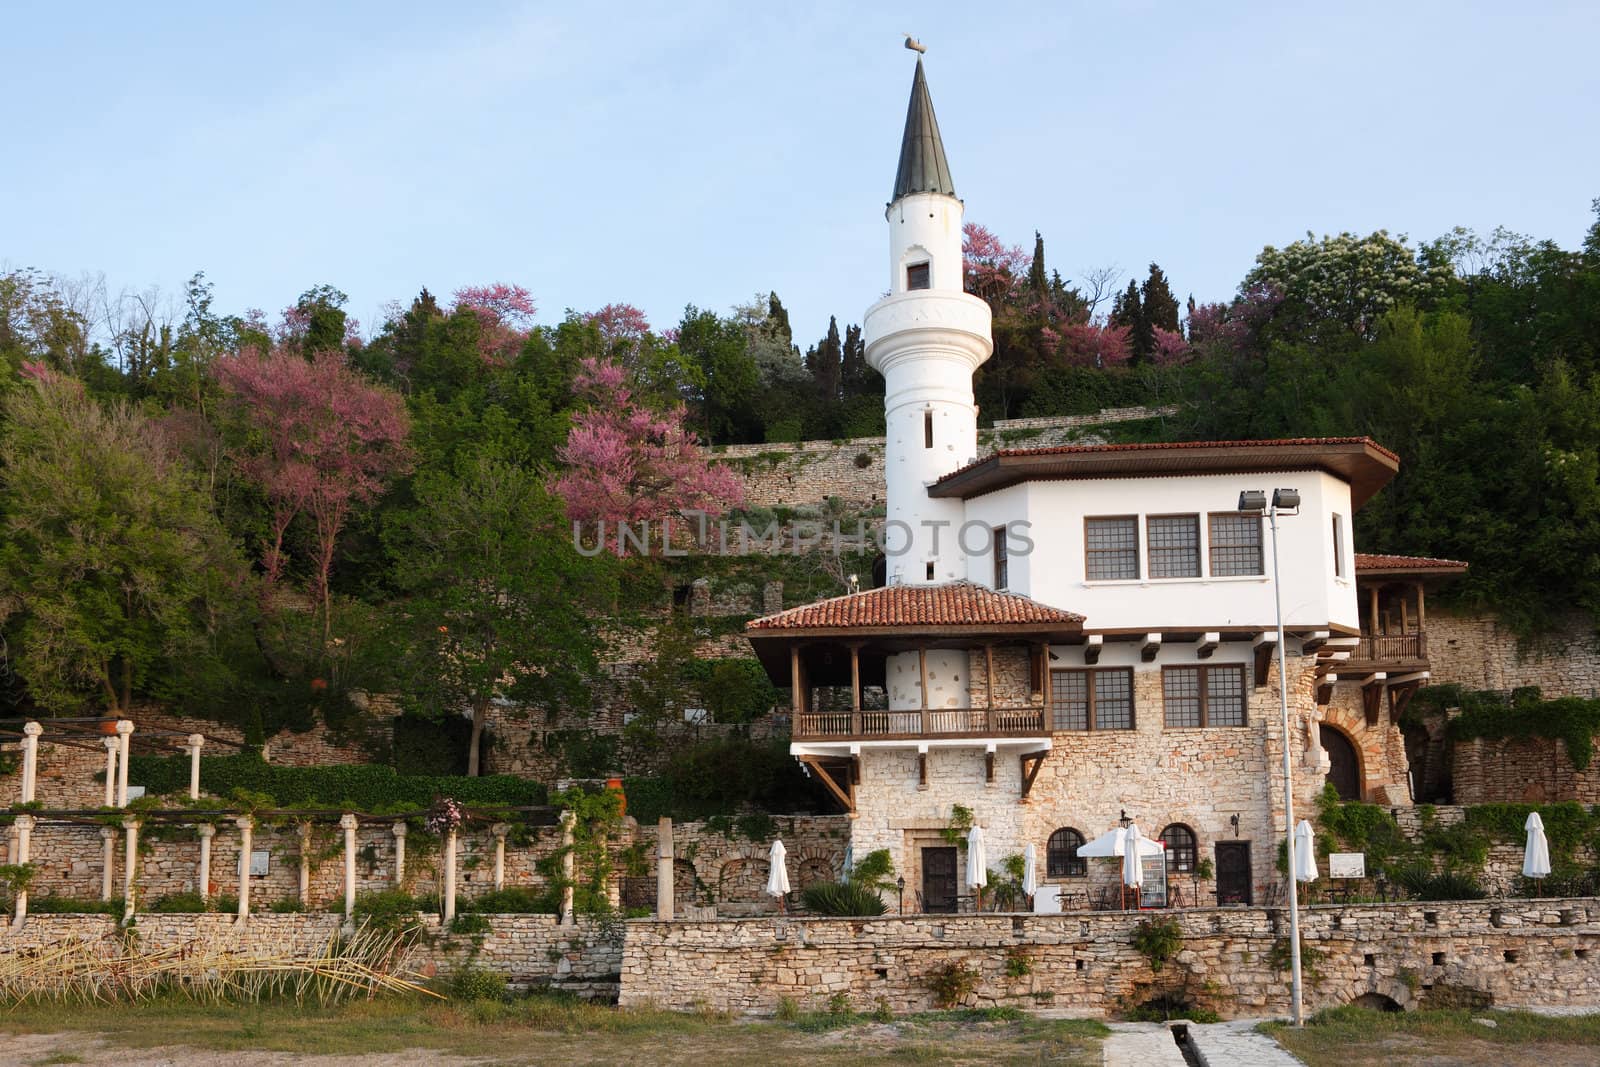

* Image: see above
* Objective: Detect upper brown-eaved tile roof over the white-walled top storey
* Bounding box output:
[928,437,1400,507]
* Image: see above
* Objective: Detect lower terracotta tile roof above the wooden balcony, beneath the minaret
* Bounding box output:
[746,582,1083,632]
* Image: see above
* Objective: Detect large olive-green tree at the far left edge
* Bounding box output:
[0,373,245,713]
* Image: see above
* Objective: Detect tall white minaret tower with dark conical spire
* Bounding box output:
[862,56,994,709]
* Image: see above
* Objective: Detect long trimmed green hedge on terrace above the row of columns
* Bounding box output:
[128,752,549,811]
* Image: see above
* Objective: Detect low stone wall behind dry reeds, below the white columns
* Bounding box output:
[0,915,622,1000]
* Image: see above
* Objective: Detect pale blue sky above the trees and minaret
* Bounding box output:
[0,0,1600,346]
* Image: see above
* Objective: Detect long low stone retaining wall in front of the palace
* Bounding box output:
[621,899,1600,1017]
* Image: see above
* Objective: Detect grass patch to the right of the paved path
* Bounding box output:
[1261,1005,1600,1067]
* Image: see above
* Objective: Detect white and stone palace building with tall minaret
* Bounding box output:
[747,58,1466,910]
